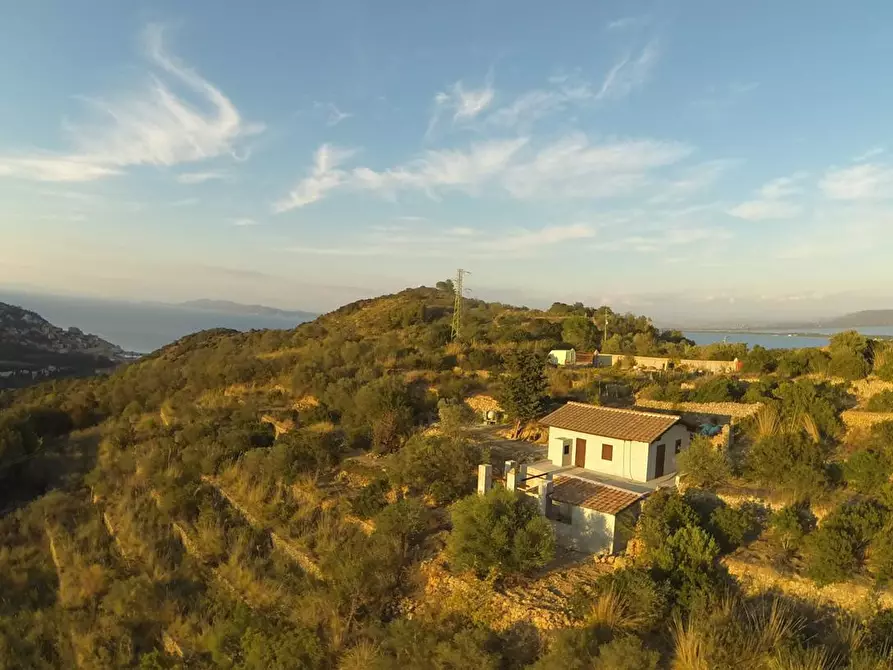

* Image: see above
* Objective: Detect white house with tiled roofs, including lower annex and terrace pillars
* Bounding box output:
[488,402,691,553]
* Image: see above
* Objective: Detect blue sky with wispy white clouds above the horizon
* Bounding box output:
[0,0,893,319]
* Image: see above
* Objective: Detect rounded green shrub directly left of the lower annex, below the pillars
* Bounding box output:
[447,488,555,576]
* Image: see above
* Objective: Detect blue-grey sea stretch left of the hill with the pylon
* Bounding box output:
[0,291,314,354]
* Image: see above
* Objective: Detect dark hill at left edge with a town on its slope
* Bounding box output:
[0,302,133,388]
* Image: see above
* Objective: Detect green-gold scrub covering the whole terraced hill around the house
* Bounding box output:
[0,285,893,670]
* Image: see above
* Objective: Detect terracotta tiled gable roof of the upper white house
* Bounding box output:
[540,402,679,442]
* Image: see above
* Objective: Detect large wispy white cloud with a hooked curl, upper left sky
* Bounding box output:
[0,25,263,182]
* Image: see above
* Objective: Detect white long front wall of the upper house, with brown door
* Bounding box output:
[549,426,654,482]
